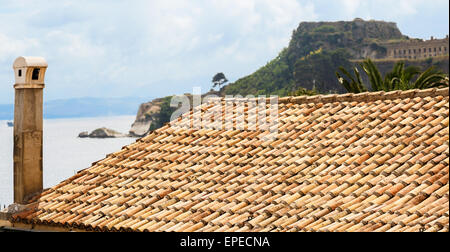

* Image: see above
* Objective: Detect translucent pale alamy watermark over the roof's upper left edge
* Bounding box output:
[170,87,279,140]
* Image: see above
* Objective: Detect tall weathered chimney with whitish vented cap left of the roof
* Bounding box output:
[13,57,48,204]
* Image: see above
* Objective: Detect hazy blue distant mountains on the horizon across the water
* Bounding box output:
[0,97,155,120]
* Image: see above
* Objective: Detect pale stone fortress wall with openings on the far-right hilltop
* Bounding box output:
[383,35,449,59]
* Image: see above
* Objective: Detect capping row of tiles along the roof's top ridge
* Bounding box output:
[210,87,449,104]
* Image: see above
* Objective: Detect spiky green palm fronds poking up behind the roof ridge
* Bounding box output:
[336,59,448,93]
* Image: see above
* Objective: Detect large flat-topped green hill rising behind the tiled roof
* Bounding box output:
[221,19,408,96]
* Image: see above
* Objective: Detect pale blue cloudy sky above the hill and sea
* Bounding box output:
[0,0,449,104]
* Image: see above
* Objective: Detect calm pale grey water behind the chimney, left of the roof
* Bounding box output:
[0,116,136,208]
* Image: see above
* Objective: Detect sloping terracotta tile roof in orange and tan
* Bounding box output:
[8,88,449,232]
